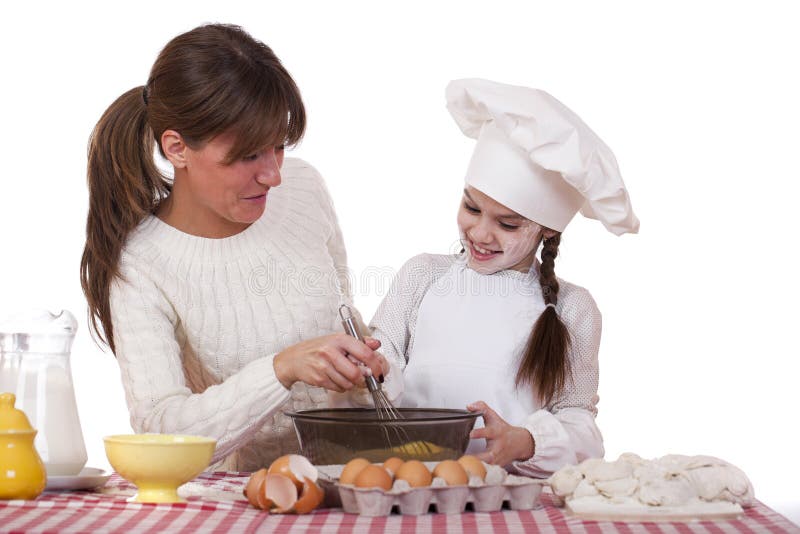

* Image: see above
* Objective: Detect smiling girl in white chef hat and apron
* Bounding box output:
[370,80,639,476]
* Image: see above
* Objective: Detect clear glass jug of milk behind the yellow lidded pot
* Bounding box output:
[0,310,86,476]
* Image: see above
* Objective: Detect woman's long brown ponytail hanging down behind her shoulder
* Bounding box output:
[81,86,171,352]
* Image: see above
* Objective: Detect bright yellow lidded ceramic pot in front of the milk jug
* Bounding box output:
[0,393,47,499]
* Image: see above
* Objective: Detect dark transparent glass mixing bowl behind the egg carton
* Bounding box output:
[286,408,483,465]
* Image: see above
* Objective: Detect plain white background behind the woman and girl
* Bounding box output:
[0,0,800,522]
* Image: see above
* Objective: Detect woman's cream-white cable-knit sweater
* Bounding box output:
[111,158,351,470]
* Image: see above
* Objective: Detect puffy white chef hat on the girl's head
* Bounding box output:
[446,79,639,235]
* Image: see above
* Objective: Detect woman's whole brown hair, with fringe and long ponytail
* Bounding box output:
[81,24,306,351]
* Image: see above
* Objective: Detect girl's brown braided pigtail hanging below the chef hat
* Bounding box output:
[516,233,570,404]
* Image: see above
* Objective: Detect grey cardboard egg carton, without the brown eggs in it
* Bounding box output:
[318,462,544,517]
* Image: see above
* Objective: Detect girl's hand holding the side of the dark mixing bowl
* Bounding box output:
[467,401,536,466]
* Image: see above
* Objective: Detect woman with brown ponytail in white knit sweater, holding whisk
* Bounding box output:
[81,24,388,470]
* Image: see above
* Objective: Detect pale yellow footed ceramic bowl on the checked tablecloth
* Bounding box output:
[103,434,217,502]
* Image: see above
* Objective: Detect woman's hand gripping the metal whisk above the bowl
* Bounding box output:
[273,334,388,393]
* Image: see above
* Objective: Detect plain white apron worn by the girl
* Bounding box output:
[402,259,544,453]
